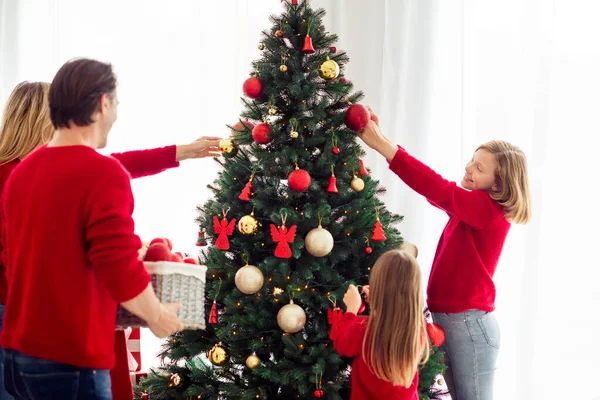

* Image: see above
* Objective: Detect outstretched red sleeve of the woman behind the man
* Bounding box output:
[111,145,179,178]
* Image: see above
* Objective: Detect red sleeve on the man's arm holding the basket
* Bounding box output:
[85,163,150,303]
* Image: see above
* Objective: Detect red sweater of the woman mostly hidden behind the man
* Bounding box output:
[0,145,179,304]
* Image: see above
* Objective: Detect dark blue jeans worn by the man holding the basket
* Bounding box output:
[4,349,112,400]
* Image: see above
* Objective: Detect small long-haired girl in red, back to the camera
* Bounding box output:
[333,250,429,400]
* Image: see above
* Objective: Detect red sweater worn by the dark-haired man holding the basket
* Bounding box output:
[0,146,176,368]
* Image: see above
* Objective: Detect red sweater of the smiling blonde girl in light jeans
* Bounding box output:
[390,147,510,313]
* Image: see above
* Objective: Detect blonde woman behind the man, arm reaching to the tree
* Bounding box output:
[0,82,220,400]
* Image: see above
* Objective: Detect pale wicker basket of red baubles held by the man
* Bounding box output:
[117,261,206,329]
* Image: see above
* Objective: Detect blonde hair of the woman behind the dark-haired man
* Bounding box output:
[0,82,54,164]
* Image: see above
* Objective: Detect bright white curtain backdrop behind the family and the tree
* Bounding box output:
[0,0,600,400]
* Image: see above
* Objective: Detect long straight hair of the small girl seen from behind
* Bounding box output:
[362,250,429,387]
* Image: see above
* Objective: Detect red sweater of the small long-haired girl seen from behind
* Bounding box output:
[333,313,419,400]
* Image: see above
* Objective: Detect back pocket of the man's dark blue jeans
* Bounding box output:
[20,371,79,400]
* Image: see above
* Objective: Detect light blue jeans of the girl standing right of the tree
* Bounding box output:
[432,310,500,400]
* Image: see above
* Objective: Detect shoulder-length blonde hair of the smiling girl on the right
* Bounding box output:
[477,140,531,224]
